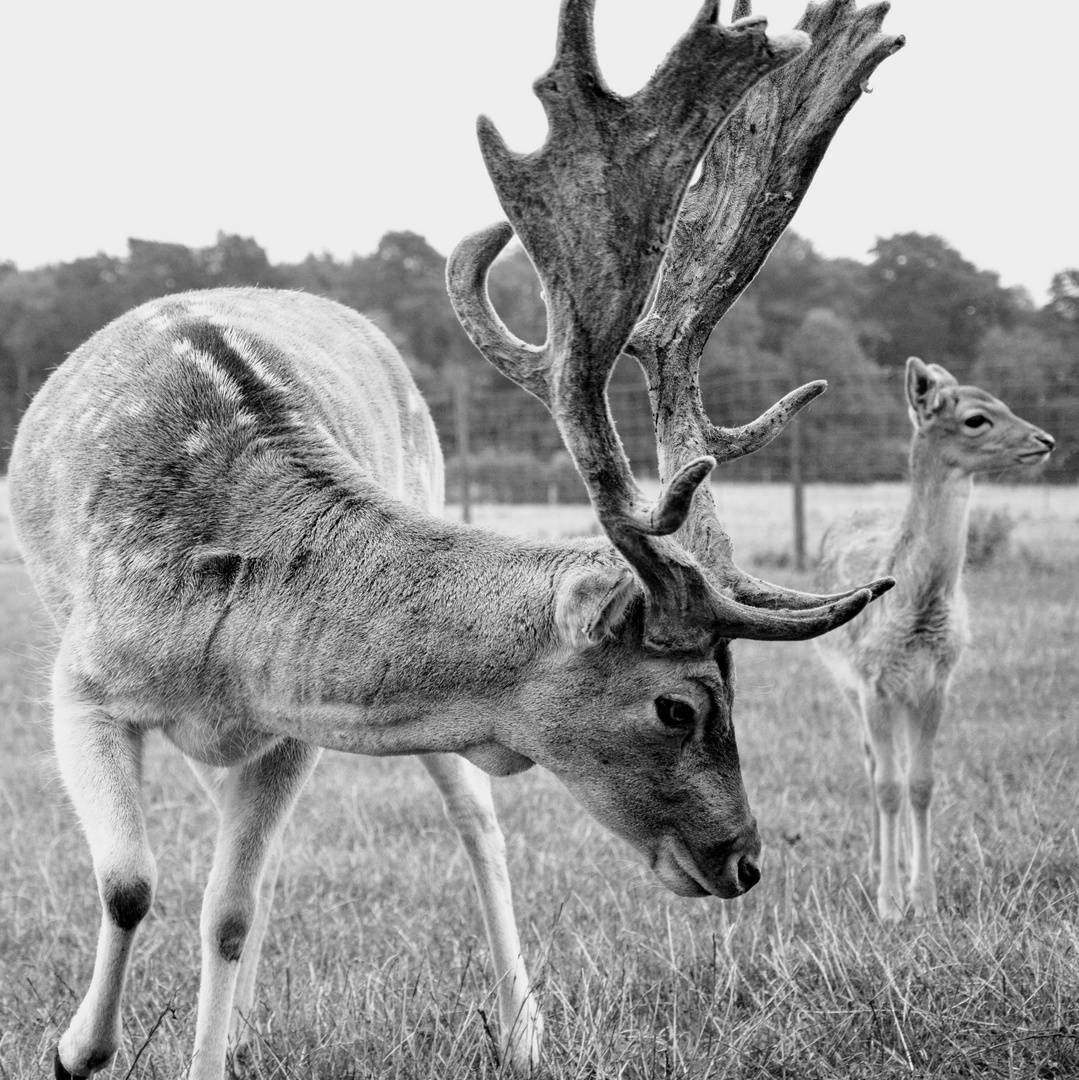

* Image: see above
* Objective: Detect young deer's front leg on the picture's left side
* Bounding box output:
[865,693,904,922]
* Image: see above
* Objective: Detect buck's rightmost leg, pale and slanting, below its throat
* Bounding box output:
[420,754,543,1075]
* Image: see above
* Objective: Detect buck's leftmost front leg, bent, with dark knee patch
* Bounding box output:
[53,664,158,1080]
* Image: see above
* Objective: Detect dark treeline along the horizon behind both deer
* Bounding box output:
[0,232,1079,483]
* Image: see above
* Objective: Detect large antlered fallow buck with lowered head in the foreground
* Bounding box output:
[11,0,902,1080]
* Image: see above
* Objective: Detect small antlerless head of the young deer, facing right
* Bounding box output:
[906,356,1056,475]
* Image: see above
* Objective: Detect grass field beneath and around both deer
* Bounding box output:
[0,488,1079,1080]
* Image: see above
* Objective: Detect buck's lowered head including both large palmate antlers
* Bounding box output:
[447,0,902,895]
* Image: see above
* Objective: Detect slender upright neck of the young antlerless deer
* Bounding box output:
[893,435,973,595]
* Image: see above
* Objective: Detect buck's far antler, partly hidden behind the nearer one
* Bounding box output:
[626,0,904,610]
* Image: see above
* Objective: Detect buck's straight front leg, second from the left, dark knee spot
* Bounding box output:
[189,739,319,1080]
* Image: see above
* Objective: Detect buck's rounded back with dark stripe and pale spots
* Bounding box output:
[12,288,443,618]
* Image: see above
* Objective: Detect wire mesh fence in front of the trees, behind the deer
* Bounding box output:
[427,369,1079,494]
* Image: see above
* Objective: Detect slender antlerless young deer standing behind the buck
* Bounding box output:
[818,356,1054,921]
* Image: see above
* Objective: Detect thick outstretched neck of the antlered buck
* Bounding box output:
[223,481,596,772]
